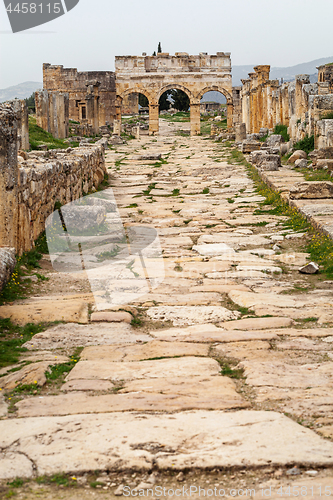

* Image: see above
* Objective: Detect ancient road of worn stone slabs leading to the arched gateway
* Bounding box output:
[0,122,333,492]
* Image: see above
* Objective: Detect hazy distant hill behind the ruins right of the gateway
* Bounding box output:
[232,56,333,86]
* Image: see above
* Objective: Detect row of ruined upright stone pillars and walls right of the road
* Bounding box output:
[240,64,333,148]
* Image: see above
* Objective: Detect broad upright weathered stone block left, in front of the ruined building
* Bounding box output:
[35,90,69,139]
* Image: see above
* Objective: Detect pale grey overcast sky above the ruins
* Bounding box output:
[0,0,333,88]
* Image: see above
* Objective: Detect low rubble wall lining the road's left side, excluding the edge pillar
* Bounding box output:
[16,140,106,253]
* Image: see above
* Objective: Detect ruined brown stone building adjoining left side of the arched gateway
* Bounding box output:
[43,64,116,126]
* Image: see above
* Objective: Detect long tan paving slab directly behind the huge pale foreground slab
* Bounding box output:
[17,376,250,417]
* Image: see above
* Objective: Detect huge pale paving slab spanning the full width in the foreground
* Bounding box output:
[0,410,333,478]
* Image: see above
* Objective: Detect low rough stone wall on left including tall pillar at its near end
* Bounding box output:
[0,104,106,254]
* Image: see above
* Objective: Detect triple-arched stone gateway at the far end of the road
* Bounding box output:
[116,52,233,135]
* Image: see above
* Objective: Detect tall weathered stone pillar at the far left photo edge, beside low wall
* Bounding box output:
[0,104,18,248]
